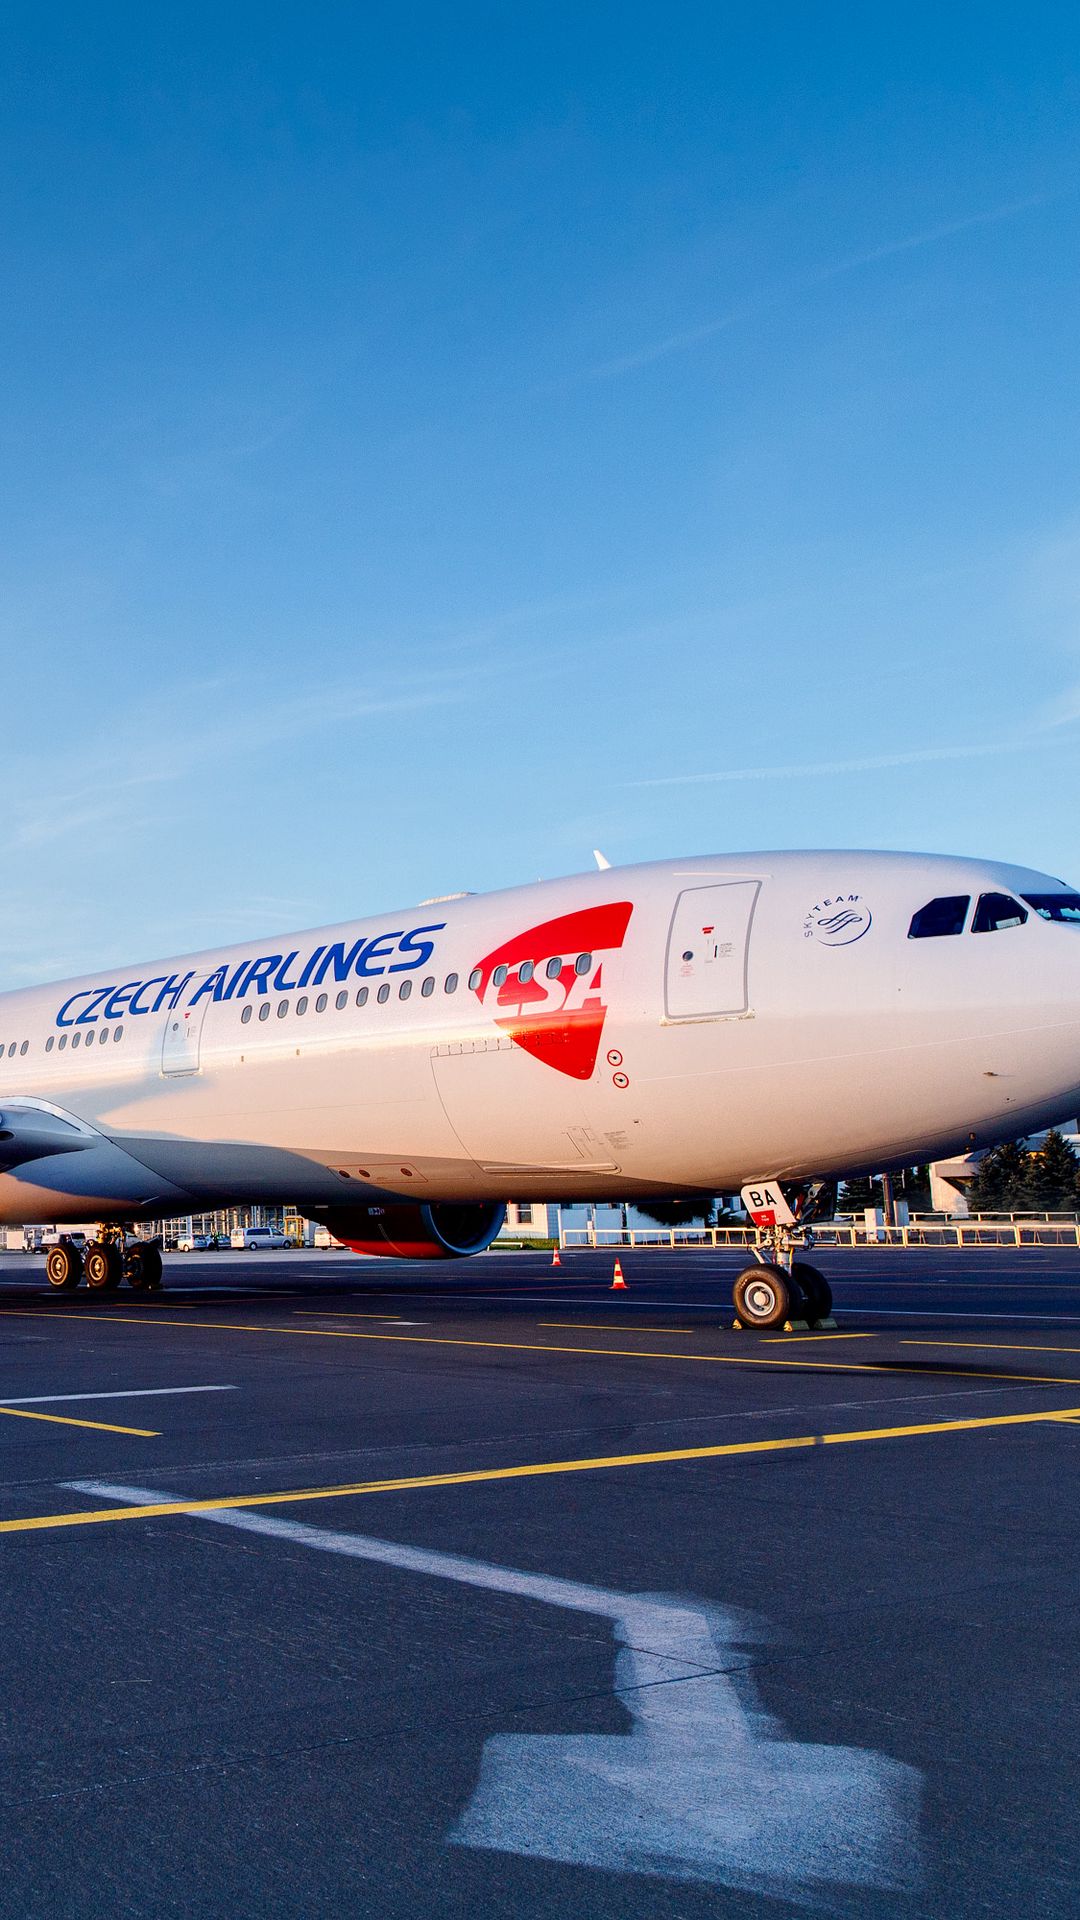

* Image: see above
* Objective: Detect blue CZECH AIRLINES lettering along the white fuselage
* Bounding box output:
[56,920,446,1027]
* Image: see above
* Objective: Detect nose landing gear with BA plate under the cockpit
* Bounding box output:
[732,1181,832,1329]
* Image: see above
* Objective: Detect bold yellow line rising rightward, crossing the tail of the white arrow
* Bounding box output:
[0,1407,1080,1534]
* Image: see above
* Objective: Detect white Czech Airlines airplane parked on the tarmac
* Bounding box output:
[0,851,1080,1327]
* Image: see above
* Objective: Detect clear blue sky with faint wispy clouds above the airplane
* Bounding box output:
[0,4,1080,985]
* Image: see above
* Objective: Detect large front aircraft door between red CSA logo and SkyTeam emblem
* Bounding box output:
[665,879,761,1020]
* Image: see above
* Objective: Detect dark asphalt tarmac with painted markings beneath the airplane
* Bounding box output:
[0,1248,1080,1920]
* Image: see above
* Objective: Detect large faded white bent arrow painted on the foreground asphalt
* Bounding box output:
[67,1480,920,1912]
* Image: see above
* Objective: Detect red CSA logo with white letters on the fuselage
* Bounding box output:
[475,900,634,1079]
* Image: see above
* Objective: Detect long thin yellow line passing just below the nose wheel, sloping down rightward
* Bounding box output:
[0,1308,1080,1386]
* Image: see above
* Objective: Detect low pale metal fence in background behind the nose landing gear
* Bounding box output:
[561,1213,1080,1248]
